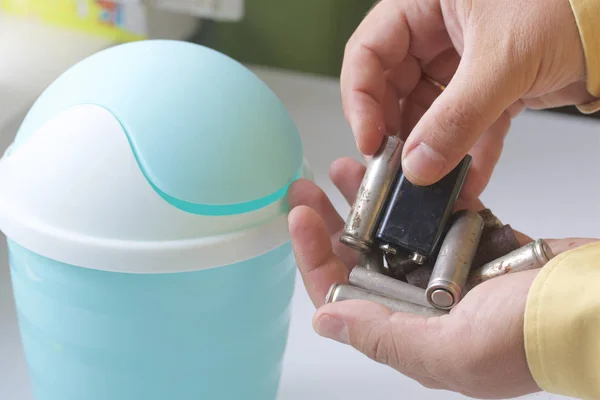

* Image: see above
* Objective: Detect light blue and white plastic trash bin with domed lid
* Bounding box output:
[0,41,310,400]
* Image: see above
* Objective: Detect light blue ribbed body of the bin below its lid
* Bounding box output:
[9,242,296,400]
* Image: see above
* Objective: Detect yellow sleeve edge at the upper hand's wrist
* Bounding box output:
[570,0,600,114]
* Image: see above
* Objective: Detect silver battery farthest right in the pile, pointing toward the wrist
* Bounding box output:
[467,239,554,288]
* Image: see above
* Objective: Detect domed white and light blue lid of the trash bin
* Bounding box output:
[0,41,305,273]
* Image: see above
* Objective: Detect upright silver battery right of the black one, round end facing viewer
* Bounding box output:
[426,210,483,310]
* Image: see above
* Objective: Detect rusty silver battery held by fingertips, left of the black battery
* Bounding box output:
[340,136,404,252]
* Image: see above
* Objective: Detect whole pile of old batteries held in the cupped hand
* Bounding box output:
[326,136,553,316]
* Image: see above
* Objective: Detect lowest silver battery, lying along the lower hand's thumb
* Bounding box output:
[325,283,447,317]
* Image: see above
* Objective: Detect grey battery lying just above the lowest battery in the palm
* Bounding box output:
[348,267,430,307]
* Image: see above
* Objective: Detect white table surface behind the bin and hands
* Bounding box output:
[0,64,600,400]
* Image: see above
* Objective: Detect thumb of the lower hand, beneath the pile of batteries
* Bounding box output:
[313,300,446,378]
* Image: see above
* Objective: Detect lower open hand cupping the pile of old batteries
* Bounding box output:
[289,159,595,399]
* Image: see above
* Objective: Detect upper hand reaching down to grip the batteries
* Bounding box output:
[341,0,594,205]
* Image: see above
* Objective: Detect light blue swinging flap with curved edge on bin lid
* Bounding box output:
[10,40,304,215]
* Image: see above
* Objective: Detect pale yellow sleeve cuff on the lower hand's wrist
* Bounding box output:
[524,242,600,400]
